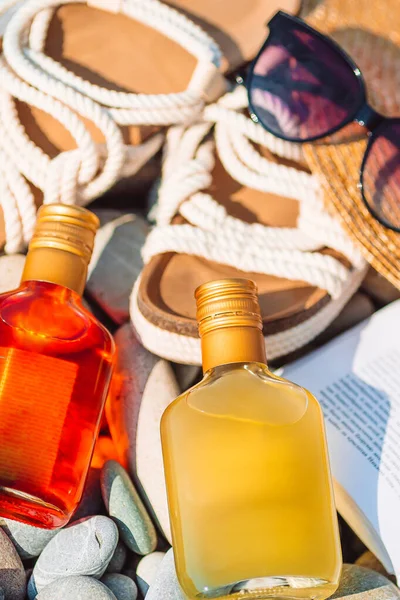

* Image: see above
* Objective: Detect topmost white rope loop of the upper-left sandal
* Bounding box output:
[4,0,223,125]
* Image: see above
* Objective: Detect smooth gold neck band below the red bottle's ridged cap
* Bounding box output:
[21,248,88,295]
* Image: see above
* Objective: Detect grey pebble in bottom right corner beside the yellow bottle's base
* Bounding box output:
[332,564,400,600]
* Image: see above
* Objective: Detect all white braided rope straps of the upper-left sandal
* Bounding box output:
[0,0,221,252]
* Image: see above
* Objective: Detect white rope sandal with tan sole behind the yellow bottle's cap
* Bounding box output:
[130,86,366,364]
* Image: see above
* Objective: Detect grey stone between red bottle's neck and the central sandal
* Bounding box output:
[87,210,149,324]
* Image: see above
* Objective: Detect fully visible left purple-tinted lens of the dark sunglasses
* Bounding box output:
[249,23,363,141]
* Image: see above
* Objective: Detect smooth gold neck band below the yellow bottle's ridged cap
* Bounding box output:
[201,326,267,373]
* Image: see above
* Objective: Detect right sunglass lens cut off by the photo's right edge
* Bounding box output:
[362,120,400,231]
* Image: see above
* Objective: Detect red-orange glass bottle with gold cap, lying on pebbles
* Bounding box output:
[0,204,114,529]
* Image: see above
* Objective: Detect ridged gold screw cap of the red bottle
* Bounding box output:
[29,204,100,262]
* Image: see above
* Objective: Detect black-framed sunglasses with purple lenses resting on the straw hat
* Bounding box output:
[247,11,400,232]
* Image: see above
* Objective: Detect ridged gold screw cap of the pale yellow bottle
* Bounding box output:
[195,279,262,336]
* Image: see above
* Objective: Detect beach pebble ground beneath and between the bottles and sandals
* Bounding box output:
[0,210,400,600]
